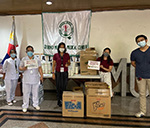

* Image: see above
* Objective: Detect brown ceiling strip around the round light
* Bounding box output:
[0,0,150,15]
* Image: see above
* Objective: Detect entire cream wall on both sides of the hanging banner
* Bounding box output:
[0,10,150,62]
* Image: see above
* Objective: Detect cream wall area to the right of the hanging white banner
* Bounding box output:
[90,10,150,62]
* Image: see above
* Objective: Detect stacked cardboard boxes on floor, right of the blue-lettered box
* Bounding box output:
[85,82,111,118]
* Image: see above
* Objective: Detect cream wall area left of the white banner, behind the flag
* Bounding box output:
[0,15,43,58]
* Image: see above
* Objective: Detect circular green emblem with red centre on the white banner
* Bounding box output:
[59,21,74,39]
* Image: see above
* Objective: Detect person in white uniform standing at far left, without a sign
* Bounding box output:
[3,49,20,106]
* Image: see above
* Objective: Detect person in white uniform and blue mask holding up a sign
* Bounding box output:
[19,46,43,112]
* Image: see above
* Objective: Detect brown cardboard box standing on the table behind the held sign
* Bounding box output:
[80,48,97,75]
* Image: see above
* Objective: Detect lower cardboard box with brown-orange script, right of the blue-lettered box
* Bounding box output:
[86,95,111,118]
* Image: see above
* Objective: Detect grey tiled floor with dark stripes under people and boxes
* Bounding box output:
[0,92,150,128]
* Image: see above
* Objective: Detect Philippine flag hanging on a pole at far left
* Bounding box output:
[1,16,18,64]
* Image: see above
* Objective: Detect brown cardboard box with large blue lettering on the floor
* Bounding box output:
[62,91,84,117]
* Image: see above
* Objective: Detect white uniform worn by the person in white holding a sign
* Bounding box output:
[20,56,41,108]
